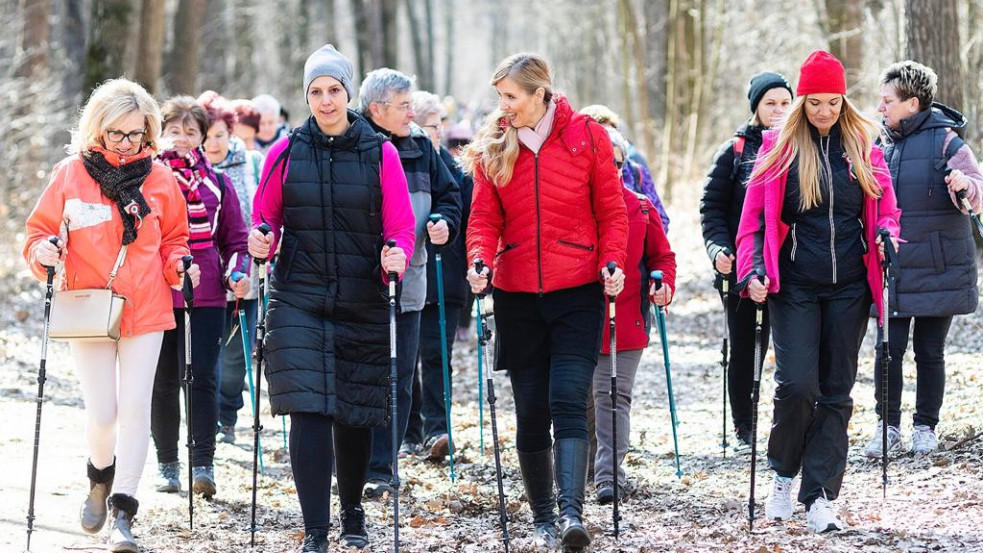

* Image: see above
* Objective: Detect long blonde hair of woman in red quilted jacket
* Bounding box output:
[460,54,553,186]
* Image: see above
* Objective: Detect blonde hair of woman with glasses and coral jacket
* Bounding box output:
[67,78,161,155]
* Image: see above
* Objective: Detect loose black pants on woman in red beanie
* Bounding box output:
[768,279,871,507]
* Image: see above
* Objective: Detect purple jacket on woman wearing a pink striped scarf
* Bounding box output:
[172,165,251,308]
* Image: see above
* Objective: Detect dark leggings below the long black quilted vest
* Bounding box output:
[290,413,372,532]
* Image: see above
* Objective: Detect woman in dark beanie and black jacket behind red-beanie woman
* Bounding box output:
[700,71,792,448]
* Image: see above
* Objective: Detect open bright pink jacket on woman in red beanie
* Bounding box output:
[737,130,901,316]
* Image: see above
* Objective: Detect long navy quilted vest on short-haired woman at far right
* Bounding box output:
[883,104,979,317]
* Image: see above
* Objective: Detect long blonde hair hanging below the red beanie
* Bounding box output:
[748,95,881,211]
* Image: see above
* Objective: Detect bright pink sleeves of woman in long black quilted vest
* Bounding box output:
[253,136,416,278]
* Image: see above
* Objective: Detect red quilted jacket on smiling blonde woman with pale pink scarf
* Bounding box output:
[467,94,628,294]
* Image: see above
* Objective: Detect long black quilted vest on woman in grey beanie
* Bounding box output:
[265,112,389,427]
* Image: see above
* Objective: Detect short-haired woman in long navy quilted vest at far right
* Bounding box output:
[865,61,983,459]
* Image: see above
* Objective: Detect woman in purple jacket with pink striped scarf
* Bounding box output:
[151,96,250,497]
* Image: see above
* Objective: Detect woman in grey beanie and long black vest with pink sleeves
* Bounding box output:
[249,45,414,553]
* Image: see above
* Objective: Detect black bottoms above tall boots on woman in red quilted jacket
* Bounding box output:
[495,283,604,453]
